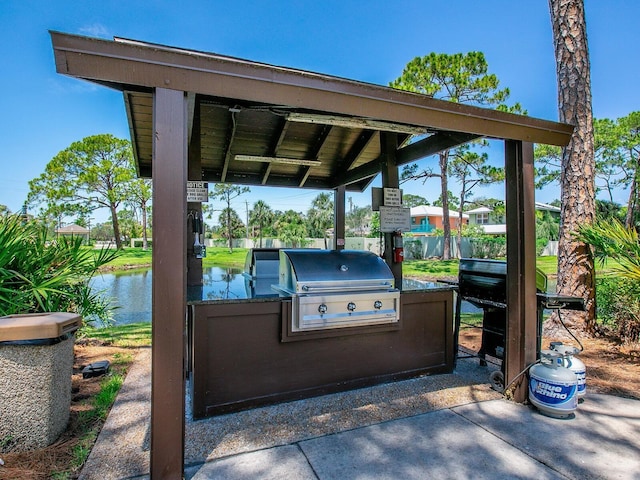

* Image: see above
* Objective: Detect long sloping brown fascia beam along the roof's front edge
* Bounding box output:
[50,32,573,146]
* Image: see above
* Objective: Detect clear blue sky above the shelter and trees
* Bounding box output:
[0,0,640,221]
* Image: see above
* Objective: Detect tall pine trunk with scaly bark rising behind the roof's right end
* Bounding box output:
[549,0,596,332]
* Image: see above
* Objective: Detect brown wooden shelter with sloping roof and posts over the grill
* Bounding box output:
[51,32,573,478]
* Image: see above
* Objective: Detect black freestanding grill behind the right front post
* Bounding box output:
[454,258,584,386]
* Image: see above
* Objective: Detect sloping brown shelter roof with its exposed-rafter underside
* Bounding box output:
[51,32,573,191]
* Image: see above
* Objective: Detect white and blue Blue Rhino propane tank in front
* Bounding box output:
[529,350,578,418]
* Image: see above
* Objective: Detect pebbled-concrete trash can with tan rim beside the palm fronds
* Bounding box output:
[0,313,82,452]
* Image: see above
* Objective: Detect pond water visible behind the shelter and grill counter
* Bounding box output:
[91,267,480,325]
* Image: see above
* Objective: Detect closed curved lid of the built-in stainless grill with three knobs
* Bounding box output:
[279,249,394,293]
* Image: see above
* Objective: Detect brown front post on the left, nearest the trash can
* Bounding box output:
[150,88,187,479]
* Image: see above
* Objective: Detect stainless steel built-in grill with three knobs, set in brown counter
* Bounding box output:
[275,249,400,332]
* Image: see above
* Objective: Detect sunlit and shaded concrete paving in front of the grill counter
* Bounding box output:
[80,352,640,480]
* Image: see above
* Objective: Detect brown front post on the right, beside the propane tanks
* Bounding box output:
[504,140,537,402]
